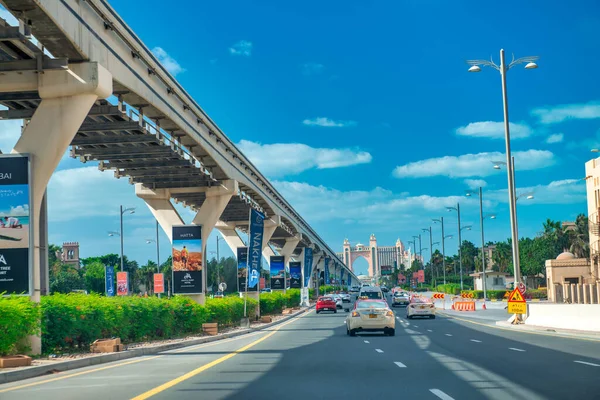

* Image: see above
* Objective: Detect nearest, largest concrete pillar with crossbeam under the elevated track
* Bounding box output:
[0,63,112,354]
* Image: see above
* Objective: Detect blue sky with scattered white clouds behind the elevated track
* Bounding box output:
[0,0,600,276]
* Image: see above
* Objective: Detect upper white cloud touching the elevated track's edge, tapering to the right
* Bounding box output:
[238,140,372,177]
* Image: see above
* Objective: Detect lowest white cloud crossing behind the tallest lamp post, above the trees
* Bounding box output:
[486,179,586,206]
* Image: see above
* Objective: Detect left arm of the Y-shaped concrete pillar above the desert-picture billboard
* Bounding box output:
[135,183,185,243]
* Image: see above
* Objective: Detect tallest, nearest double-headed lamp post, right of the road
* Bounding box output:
[467,49,539,285]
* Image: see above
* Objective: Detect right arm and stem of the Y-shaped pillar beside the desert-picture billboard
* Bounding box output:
[190,180,238,304]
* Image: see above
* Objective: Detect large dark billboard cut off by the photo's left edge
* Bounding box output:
[0,154,33,296]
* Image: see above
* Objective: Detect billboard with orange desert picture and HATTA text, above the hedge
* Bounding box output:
[172,225,204,294]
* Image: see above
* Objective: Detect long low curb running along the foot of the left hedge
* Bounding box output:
[0,306,314,384]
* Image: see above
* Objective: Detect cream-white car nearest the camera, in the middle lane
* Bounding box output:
[346,299,396,336]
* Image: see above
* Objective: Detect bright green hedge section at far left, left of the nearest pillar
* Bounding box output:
[0,296,40,356]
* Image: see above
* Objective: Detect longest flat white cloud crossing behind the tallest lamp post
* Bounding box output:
[393,150,555,178]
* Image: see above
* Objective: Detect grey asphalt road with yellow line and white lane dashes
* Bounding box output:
[0,292,600,400]
